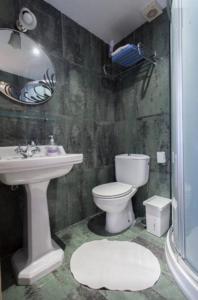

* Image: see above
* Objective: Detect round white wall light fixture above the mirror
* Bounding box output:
[16,7,37,32]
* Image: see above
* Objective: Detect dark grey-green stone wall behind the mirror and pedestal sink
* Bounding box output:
[0,0,115,254]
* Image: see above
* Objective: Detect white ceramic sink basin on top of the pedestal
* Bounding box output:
[0,146,83,185]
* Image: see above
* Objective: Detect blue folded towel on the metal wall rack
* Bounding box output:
[111,44,144,67]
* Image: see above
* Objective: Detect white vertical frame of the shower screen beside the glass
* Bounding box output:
[171,0,185,258]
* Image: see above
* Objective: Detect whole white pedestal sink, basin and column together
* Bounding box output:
[0,146,83,285]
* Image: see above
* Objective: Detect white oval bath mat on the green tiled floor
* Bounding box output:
[70,240,160,291]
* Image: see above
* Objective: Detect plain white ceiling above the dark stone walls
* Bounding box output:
[45,0,166,43]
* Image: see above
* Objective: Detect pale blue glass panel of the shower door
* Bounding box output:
[182,0,198,271]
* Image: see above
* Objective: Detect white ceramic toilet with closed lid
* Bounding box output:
[92,154,150,233]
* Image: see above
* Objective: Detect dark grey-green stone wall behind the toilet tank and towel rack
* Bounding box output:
[115,11,170,216]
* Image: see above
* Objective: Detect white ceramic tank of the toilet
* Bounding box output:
[115,154,150,188]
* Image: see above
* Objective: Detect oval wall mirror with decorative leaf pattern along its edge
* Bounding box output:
[0,29,56,105]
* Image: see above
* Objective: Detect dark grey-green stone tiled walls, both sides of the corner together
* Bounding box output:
[0,0,170,255]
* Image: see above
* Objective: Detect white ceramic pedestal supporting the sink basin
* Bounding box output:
[12,181,64,285]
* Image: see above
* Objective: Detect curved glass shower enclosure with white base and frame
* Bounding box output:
[165,0,198,300]
